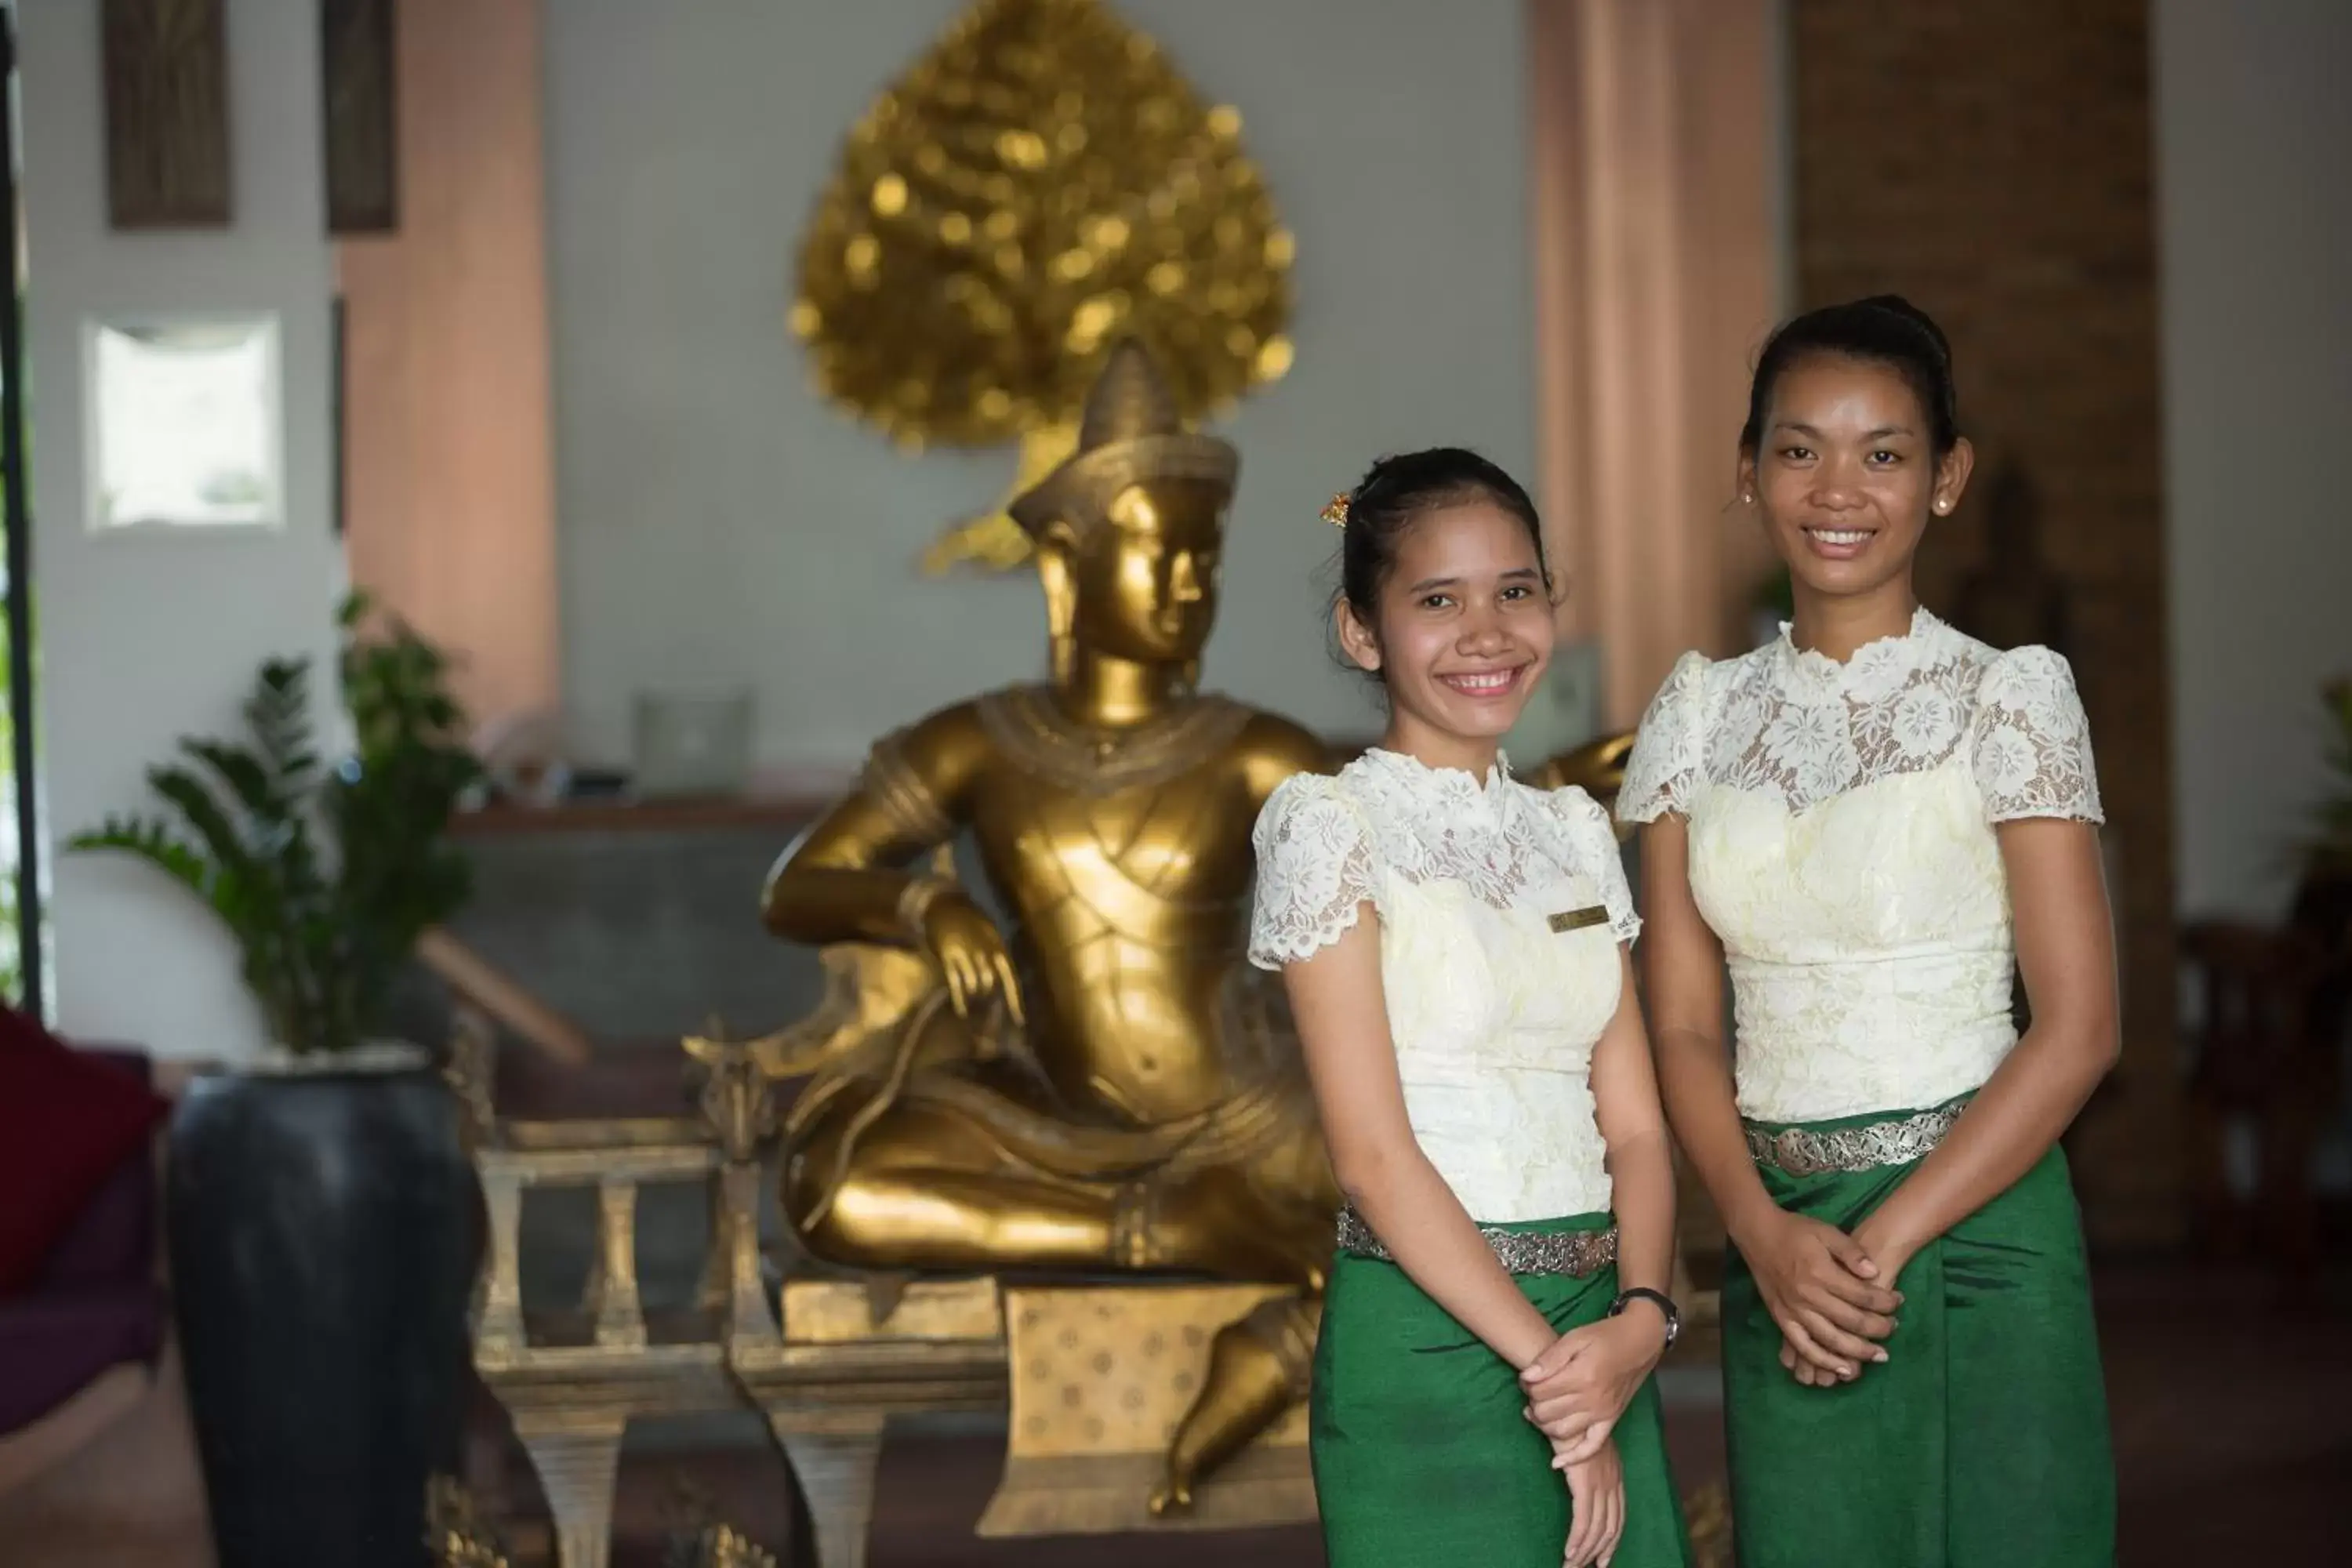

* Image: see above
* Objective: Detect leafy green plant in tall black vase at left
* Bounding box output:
[73,597,477,1568]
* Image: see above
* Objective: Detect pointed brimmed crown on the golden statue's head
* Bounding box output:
[1007,339,1242,536]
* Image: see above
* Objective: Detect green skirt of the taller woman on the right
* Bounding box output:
[1724,1112,2114,1568]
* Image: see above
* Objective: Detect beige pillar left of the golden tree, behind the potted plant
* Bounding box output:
[336,0,560,720]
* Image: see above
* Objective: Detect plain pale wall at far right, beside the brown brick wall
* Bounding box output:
[2154,0,2352,916]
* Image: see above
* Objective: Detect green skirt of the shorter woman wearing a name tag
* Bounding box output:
[1308,1215,1691,1568]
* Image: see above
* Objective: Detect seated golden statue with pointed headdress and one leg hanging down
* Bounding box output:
[762,343,1338,1512]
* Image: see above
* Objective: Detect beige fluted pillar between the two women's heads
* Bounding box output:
[1529,0,1783,727]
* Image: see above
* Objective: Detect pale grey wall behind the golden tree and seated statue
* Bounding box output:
[543,0,1534,767]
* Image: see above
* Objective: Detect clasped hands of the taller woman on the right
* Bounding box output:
[1740,1213,1907,1387]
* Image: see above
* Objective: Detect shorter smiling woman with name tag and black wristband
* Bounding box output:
[1249,449,1689,1568]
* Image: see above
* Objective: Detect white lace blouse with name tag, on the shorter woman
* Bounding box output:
[1249,750,1642,1225]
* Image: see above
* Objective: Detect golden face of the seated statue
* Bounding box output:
[1075,480,1225,666]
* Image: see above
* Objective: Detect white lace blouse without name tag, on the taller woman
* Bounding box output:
[1618,609,2100,1121]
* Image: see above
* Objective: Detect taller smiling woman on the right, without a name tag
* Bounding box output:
[1618,299,2117,1568]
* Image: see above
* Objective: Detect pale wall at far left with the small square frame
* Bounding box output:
[16,0,341,1055]
